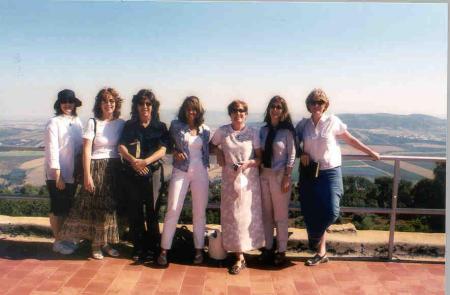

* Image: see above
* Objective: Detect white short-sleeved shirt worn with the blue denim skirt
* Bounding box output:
[295,115,347,170]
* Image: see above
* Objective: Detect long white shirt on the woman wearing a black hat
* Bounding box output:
[44,115,83,183]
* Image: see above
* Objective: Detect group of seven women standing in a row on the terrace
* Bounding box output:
[45,88,379,274]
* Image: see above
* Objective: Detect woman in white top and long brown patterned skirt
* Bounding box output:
[62,88,125,259]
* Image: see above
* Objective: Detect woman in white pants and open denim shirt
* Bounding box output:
[157,96,210,266]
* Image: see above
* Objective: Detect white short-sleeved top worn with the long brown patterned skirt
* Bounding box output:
[83,119,125,160]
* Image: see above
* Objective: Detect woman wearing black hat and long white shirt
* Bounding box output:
[44,89,83,254]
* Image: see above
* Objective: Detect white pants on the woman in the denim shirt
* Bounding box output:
[161,164,209,250]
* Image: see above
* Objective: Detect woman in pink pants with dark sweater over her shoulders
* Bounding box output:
[259,96,295,266]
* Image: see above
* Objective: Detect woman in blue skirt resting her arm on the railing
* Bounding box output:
[296,89,380,266]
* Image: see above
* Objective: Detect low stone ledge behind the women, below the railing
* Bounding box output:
[0,215,445,259]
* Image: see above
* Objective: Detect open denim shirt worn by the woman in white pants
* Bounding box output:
[169,120,211,172]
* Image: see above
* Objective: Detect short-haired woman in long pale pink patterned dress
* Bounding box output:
[211,100,264,274]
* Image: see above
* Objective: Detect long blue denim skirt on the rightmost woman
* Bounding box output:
[299,166,344,250]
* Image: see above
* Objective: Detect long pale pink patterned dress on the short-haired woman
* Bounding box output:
[211,125,265,252]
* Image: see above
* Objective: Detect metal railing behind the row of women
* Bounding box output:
[0,146,446,260]
